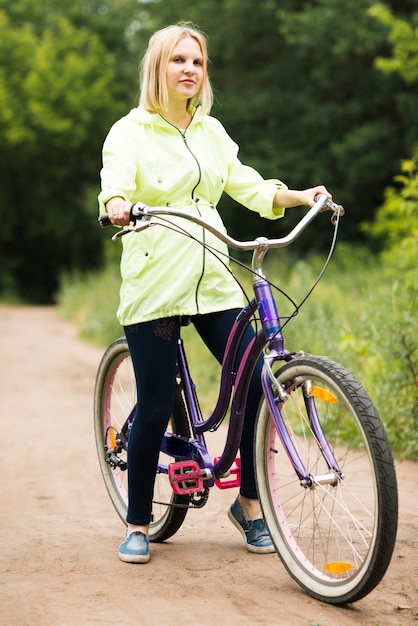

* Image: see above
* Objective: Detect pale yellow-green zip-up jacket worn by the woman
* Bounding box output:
[99,107,285,326]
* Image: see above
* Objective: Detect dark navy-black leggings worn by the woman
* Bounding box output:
[124,309,262,526]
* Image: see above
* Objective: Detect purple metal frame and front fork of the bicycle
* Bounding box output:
[167,277,341,486]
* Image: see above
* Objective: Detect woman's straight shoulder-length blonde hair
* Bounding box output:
[139,23,213,113]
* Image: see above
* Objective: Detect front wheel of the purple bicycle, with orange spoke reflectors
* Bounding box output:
[255,356,398,604]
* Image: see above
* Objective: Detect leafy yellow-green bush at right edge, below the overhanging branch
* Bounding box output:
[364,156,418,454]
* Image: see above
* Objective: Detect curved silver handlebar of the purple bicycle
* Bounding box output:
[99,194,345,256]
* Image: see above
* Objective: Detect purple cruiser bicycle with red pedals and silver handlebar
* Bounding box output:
[94,195,398,605]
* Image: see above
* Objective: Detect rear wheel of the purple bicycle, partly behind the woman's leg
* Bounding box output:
[94,338,189,542]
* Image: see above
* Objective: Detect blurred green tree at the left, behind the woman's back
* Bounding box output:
[0,2,116,301]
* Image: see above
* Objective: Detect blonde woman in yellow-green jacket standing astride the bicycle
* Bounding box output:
[99,24,331,563]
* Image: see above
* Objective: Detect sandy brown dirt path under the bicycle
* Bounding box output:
[0,307,418,626]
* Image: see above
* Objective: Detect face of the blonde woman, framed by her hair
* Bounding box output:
[167,37,204,104]
